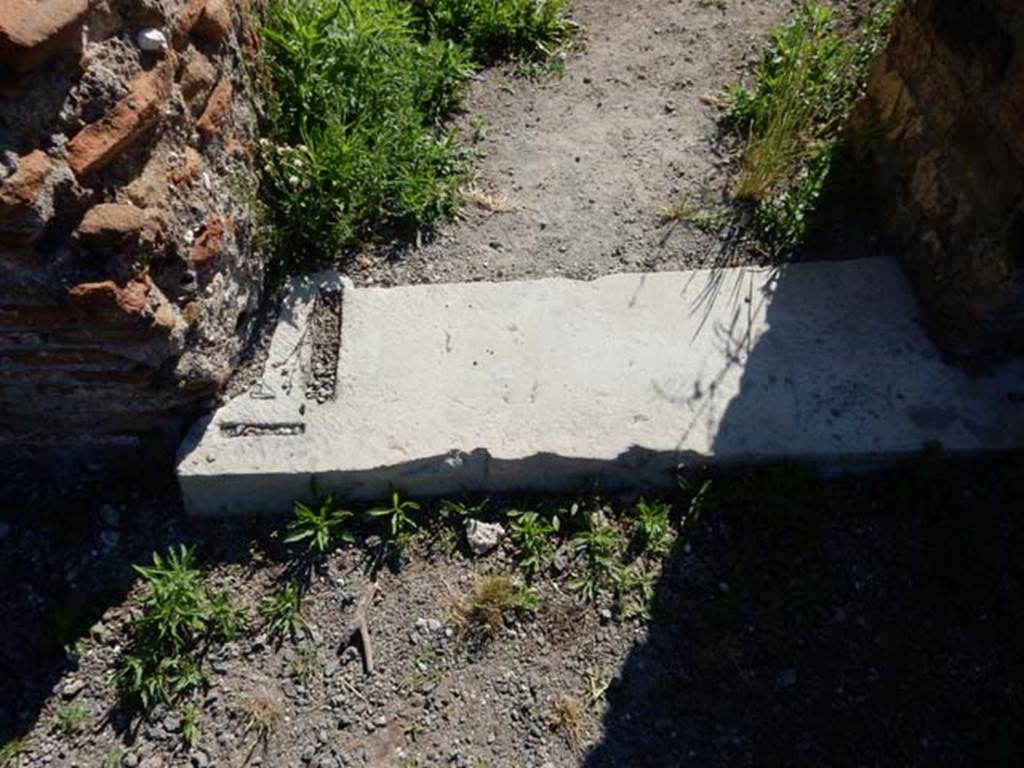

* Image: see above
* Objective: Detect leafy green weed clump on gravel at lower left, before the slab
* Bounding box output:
[117,545,247,710]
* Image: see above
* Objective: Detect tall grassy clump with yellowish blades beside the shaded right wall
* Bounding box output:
[726,0,897,253]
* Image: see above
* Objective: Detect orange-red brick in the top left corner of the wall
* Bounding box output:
[0,0,89,75]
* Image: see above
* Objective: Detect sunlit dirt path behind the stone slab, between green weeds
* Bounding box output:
[358,0,880,285]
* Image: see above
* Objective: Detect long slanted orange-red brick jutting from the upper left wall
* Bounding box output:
[68,52,175,176]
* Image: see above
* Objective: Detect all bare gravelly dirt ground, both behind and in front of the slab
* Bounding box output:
[0,0,1024,768]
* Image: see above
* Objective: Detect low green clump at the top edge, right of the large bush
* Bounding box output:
[413,0,575,63]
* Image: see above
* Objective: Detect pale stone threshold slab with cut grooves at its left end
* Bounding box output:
[178,259,1024,514]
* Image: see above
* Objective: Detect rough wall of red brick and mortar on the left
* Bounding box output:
[0,0,263,443]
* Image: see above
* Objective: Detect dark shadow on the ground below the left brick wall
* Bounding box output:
[0,473,280,744]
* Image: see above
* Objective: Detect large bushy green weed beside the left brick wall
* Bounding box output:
[259,0,472,263]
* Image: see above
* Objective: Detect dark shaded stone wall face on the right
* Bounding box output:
[860,0,1024,362]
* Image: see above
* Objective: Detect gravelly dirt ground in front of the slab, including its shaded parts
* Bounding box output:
[0,456,1024,768]
